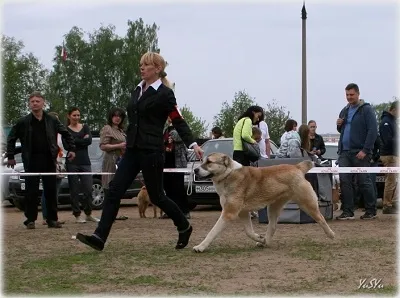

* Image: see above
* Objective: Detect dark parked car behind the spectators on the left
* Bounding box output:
[5,137,142,210]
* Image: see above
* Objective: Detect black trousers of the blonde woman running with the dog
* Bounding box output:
[94,148,190,242]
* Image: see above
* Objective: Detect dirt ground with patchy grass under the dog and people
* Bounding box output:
[3,203,397,296]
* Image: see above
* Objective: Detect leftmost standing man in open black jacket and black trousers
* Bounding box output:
[7,91,75,229]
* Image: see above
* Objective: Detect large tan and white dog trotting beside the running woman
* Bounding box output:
[193,153,335,252]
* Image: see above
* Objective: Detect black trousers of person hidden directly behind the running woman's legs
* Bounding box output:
[164,173,189,213]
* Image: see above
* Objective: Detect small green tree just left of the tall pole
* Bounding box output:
[265,99,290,146]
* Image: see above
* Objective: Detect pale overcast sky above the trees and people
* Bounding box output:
[2,0,400,133]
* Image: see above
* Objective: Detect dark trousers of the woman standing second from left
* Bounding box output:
[66,164,93,216]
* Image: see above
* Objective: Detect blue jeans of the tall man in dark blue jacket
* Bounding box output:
[339,151,376,215]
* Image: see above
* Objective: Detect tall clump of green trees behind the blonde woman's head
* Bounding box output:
[49,18,159,130]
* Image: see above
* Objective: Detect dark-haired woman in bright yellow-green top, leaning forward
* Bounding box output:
[233,106,263,166]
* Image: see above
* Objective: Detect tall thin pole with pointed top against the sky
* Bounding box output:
[301,2,307,124]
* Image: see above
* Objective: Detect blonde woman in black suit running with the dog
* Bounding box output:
[76,52,202,250]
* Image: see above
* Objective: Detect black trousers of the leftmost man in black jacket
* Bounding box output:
[25,154,58,222]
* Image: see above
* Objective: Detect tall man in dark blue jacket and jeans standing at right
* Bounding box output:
[336,83,378,220]
